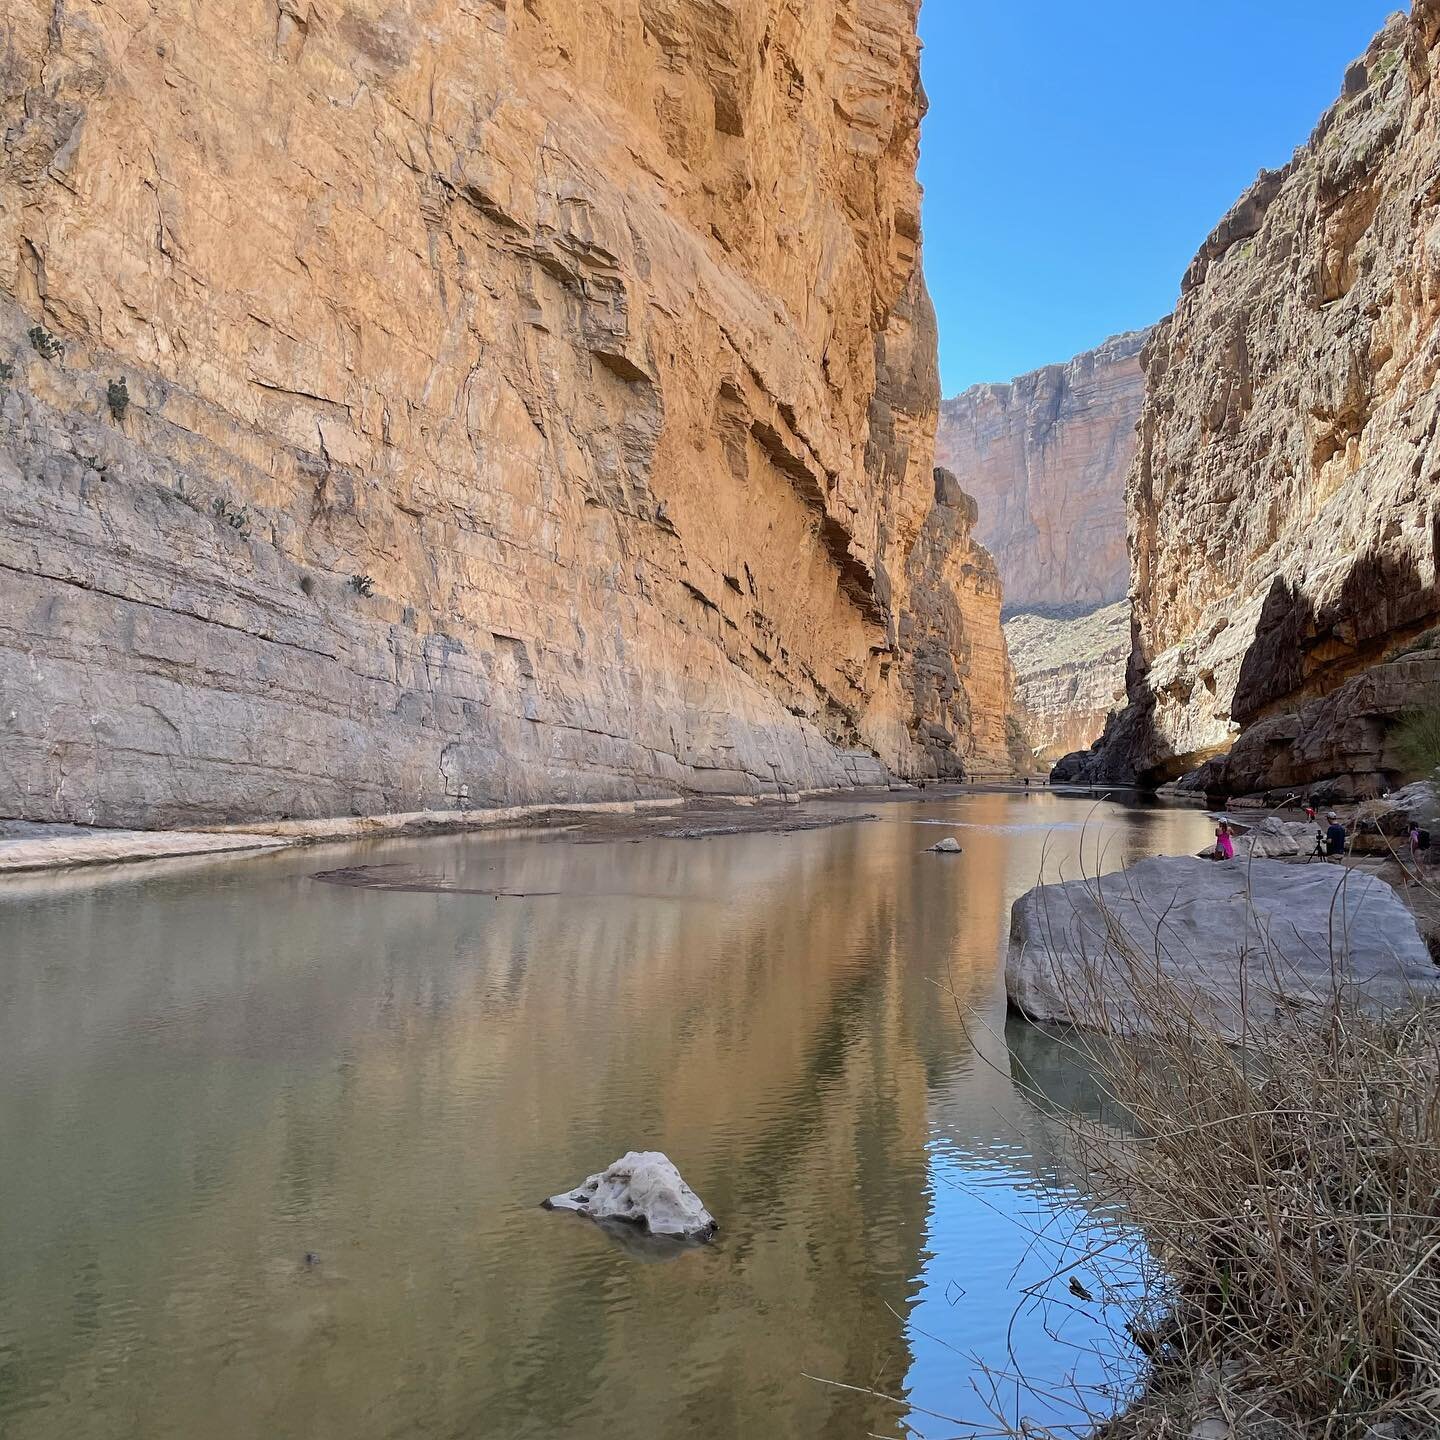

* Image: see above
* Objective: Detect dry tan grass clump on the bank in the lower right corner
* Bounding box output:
[1009,858,1440,1440]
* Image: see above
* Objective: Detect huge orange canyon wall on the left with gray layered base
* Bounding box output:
[0,0,1004,824]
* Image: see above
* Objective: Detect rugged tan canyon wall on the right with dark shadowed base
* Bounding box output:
[1063,0,1440,789]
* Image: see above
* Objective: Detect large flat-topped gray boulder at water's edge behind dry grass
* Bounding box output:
[1005,857,1440,1038]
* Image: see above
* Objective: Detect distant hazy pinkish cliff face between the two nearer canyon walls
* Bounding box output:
[937,331,1148,613]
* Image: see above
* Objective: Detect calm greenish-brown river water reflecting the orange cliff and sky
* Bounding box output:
[0,793,1208,1440]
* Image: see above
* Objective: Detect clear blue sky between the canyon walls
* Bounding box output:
[920,0,1403,396]
